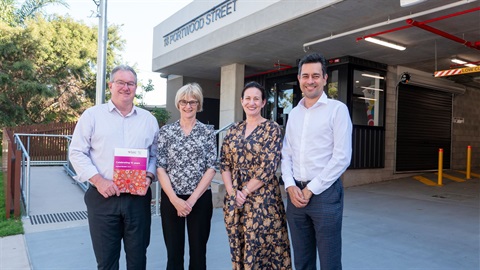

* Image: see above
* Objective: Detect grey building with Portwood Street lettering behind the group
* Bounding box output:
[152,0,480,186]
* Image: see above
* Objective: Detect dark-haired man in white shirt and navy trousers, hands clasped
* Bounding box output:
[282,53,352,270]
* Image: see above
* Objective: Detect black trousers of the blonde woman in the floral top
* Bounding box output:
[160,190,213,270]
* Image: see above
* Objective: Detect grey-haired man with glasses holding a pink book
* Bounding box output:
[69,65,159,269]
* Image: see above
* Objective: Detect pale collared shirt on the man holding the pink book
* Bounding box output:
[69,100,159,182]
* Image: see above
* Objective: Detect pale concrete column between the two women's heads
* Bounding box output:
[219,63,245,128]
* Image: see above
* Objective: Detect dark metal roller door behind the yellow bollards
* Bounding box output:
[395,84,453,172]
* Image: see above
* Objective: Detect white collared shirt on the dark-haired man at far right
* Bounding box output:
[282,93,352,195]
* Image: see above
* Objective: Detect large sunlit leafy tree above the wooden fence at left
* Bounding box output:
[0,16,125,127]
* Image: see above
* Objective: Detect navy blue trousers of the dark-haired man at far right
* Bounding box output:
[287,179,343,270]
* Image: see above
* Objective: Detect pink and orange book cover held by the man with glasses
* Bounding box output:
[113,148,148,194]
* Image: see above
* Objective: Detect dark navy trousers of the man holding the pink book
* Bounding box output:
[84,187,152,270]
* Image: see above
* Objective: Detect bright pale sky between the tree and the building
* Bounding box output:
[40,0,193,105]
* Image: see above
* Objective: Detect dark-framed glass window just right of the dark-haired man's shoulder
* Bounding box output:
[352,69,385,126]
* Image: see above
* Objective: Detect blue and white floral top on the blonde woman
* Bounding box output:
[157,120,217,195]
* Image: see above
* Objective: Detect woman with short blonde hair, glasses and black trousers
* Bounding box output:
[157,83,217,269]
